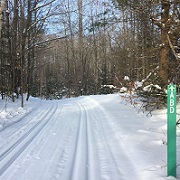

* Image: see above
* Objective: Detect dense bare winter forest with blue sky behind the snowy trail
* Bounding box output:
[0,0,180,106]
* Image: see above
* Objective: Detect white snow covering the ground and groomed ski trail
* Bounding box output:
[0,94,180,180]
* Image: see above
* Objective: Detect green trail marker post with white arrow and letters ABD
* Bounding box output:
[167,84,176,177]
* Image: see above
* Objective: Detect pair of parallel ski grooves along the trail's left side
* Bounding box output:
[0,103,58,176]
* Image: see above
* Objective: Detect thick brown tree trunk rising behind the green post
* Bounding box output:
[153,0,180,87]
